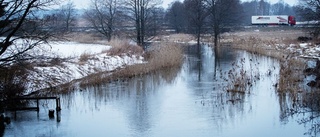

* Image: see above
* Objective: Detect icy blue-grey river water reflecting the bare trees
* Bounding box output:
[4,46,307,137]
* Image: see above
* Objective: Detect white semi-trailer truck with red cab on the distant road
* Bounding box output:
[251,15,296,25]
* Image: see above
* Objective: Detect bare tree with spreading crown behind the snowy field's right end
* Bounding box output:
[85,0,120,40]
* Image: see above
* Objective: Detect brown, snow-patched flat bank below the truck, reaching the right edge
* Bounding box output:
[221,30,320,60]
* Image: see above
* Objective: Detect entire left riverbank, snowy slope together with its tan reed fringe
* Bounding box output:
[24,39,183,95]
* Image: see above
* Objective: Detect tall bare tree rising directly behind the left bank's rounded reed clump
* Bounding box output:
[123,0,162,46]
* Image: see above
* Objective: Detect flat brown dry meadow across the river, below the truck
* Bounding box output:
[221,30,305,60]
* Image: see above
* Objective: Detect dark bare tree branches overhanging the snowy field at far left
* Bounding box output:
[0,0,54,65]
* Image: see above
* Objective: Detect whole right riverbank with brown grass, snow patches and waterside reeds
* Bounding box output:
[221,29,320,94]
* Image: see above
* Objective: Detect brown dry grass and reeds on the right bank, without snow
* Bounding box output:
[222,30,307,93]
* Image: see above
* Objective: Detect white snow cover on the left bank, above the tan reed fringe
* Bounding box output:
[26,42,144,94]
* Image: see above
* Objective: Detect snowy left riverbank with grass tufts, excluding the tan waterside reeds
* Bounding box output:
[20,41,146,95]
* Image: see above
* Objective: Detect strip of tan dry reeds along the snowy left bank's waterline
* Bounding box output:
[80,43,183,86]
